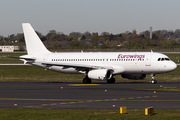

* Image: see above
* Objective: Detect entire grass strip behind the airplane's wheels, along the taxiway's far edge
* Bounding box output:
[0,65,180,82]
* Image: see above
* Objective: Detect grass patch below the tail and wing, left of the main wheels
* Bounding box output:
[0,66,84,82]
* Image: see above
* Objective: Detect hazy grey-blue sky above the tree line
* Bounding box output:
[0,0,180,37]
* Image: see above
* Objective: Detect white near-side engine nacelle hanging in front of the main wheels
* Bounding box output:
[87,69,112,80]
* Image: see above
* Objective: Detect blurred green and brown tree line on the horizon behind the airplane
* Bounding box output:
[0,29,180,50]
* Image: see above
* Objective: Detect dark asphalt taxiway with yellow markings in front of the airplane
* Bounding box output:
[0,82,180,109]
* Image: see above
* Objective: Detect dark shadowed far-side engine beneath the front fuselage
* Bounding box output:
[121,74,147,80]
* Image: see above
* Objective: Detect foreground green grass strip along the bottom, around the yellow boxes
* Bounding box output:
[0,108,180,120]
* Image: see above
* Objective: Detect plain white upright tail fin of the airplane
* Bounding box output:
[22,23,49,55]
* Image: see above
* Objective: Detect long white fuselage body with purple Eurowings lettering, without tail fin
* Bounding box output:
[27,52,177,75]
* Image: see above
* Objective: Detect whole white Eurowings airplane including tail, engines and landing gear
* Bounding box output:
[19,23,177,83]
